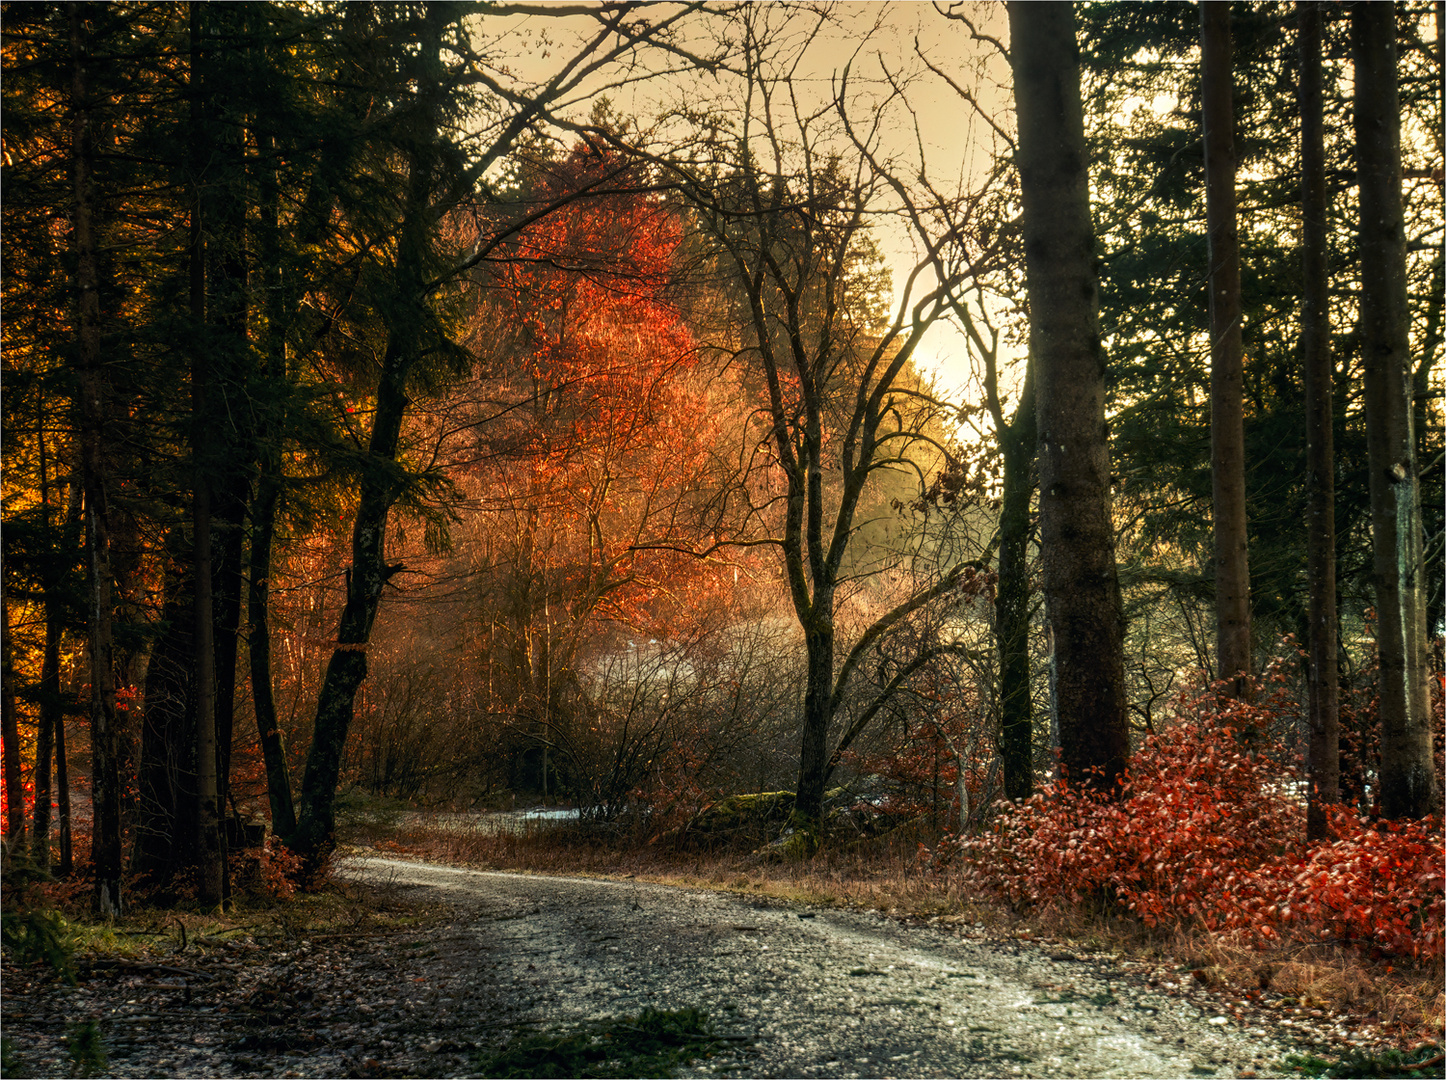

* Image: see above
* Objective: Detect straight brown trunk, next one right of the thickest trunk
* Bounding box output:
[1200,0,1251,697]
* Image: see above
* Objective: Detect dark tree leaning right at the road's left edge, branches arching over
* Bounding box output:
[289,3,734,862]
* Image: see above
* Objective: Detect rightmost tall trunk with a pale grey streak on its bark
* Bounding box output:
[1351,3,1437,818]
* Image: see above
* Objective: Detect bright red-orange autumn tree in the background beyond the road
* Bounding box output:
[451,142,736,813]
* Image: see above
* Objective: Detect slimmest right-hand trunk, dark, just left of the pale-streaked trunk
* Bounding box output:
[1296,0,1340,840]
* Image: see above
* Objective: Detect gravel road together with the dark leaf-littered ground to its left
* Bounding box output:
[0,857,1422,1077]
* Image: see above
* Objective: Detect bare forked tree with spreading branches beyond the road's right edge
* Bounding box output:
[662,9,1000,850]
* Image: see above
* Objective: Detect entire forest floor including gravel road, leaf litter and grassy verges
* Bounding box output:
[0,821,1442,1077]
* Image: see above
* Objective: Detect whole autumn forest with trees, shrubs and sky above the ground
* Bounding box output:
[0,0,1446,1006]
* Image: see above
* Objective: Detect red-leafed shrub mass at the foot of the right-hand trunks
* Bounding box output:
[934,676,1446,959]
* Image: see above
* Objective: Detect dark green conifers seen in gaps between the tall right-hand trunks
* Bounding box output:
[1079,4,1440,815]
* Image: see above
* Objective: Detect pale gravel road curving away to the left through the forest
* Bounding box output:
[340,857,1290,1077]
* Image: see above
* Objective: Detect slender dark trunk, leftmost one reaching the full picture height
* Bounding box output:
[68,3,121,917]
